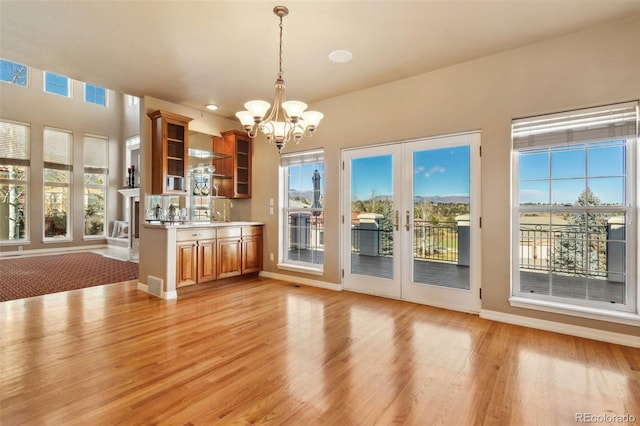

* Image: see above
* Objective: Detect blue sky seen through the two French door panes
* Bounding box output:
[351,146,469,200]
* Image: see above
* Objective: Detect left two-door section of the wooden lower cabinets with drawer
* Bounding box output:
[176,228,217,287]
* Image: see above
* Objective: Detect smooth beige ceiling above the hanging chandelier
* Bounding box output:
[0,0,640,117]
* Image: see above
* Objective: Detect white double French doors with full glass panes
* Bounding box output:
[342,133,480,312]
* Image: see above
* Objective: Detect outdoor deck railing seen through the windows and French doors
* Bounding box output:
[290,216,625,279]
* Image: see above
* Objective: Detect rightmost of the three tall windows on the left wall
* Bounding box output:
[84,135,109,237]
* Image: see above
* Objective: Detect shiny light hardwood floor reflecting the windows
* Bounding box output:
[0,277,640,425]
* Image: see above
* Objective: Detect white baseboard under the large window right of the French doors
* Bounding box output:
[480,309,640,348]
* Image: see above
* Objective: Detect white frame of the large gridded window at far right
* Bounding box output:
[509,102,640,325]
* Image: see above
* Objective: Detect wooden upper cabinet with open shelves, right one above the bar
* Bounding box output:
[213,130,251,198]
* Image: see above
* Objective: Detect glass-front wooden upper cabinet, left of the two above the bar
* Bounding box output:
[148,110,191,194]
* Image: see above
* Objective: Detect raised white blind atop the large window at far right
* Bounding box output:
[511,102,639,150]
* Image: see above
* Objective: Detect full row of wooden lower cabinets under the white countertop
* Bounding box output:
[176,225,263,287]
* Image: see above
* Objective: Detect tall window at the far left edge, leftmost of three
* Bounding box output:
[0,121,30,242]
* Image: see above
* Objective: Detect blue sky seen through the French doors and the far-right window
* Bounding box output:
[351,141,626,205]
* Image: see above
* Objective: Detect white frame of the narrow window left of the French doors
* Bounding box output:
[278,148,325,275]
